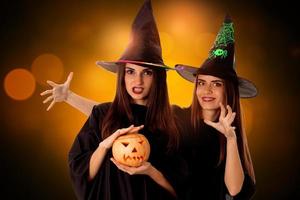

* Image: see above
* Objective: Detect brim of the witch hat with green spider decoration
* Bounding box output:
[175,64,258,98]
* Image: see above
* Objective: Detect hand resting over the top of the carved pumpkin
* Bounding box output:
[99,125,144,149]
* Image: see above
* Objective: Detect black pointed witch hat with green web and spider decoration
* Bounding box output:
[175,15,257,98]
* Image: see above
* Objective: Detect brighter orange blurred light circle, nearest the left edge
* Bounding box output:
[4,68,35,100]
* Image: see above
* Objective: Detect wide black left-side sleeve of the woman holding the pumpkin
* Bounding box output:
[69,106,109,199]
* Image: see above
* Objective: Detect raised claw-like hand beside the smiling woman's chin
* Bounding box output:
[204,103,236,139]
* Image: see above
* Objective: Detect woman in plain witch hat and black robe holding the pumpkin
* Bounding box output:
[62,0,183,200]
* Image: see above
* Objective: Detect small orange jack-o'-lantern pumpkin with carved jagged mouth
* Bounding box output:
[112,133,150,167]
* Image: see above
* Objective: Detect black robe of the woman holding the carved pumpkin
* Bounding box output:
[69,103,180,200]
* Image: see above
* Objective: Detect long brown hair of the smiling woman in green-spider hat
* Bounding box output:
[191,79,255,183]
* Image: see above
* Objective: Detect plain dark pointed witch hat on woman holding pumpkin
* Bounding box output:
[96,0,174,72]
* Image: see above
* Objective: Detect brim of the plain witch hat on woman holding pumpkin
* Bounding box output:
[96,60,175,73]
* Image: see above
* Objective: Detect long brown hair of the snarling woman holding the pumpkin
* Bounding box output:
[100,65,178,150]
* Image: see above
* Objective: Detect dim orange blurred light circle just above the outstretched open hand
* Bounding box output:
[31,54,64,85]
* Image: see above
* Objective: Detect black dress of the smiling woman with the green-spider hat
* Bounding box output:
[174,107,255,200]
